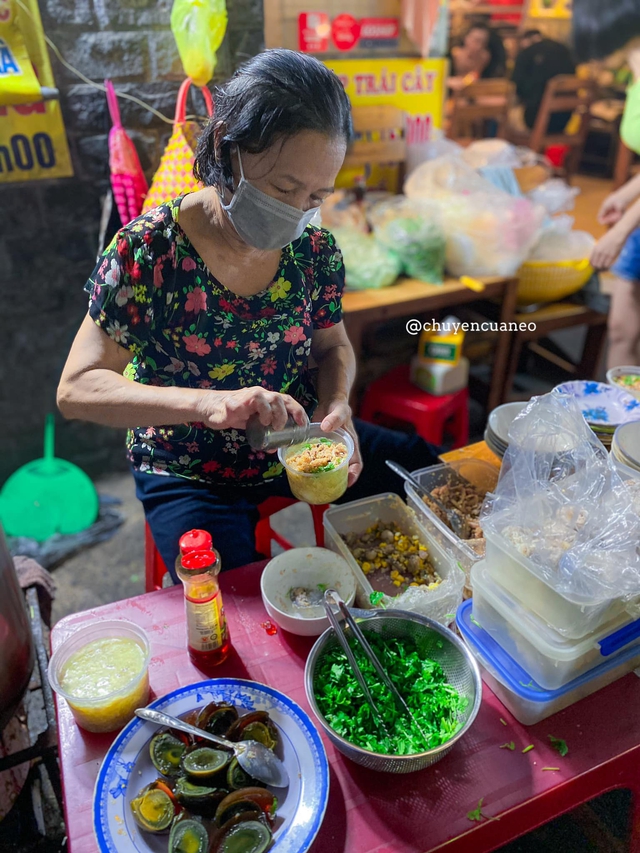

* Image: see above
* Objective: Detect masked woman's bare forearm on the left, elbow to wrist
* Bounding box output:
[58,368,208,427]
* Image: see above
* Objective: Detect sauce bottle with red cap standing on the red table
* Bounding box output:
[176,544,231,673]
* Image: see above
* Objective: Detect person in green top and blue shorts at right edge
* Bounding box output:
[573,0,640,368]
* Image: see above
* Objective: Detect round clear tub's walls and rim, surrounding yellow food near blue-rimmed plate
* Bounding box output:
[48,619,150,732]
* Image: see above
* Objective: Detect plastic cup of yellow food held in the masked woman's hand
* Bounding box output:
[278,424,354,504]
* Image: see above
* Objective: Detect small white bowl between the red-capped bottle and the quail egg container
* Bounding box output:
[260,548,356,637]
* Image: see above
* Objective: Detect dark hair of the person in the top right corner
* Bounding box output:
[573,0,640,62]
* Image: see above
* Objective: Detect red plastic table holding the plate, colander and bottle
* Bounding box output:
[52,563,640,853]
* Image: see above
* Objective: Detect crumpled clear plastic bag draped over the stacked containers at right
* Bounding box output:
[481,391,640,604]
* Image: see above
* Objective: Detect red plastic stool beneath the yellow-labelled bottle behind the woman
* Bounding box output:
[360,365,469,447]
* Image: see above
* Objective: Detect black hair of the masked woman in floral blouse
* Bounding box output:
[193,49,353,188]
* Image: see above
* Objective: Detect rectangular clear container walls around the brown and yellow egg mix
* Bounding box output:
[324,492,465,624]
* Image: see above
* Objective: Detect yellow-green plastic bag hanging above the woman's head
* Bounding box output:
[171,0,227,87]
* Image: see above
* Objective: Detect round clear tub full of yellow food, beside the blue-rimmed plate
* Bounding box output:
[49,620,150,732]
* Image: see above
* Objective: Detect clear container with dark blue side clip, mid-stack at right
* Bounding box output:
[471,561,640,690]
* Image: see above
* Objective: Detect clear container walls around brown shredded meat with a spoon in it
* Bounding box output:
[405,459,500,585]
